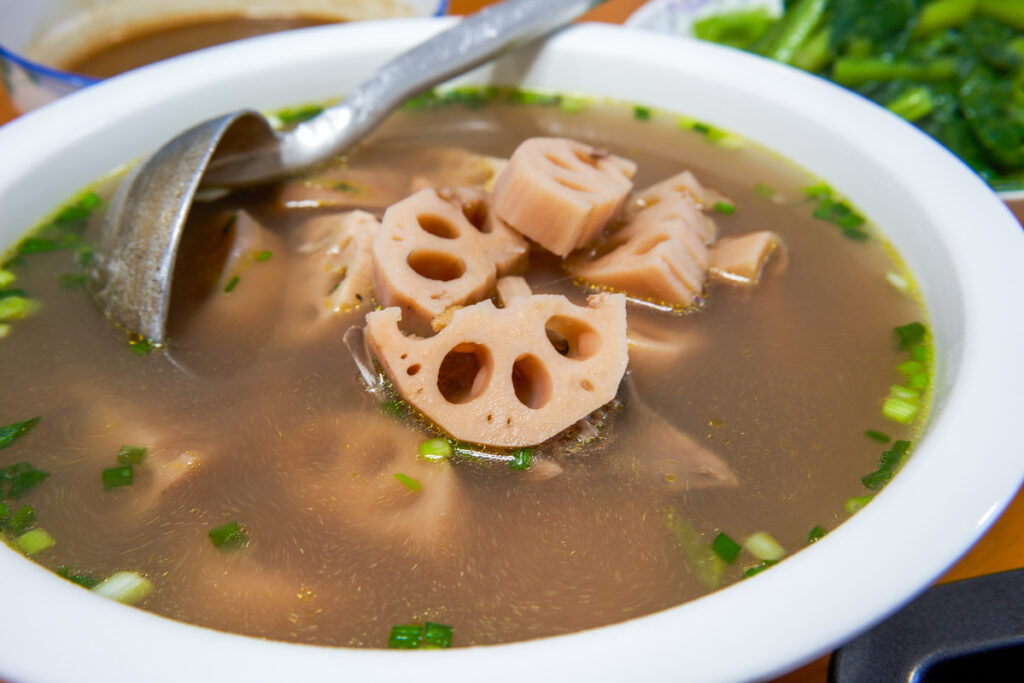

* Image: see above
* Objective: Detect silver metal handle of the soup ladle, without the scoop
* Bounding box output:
[207,0,604,185]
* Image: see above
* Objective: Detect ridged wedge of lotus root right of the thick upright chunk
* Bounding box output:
[568,195,711,306]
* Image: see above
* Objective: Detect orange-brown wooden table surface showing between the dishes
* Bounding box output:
[0,0,1024,683]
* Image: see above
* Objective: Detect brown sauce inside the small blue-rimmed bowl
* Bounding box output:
[60,14,339,78]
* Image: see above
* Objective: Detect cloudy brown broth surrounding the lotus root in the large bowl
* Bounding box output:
[0,97,923,647]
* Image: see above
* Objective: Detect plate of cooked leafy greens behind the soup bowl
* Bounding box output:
[626,0,1024,199]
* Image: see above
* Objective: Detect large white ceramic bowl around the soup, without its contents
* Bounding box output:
[0,19,1024,683]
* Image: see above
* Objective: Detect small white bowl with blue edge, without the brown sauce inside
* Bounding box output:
[0,0,447,112]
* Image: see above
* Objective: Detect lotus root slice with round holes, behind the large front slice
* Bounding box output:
[373,188,528,327]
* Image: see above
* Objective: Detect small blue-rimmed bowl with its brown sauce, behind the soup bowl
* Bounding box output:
[0,0,447,113]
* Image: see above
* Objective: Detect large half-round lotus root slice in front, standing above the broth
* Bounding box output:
[367,293,629,447]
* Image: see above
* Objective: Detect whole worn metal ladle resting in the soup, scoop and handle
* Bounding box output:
[89,0,603,343]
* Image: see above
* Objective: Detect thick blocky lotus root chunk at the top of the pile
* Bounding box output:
[494,137,636,257]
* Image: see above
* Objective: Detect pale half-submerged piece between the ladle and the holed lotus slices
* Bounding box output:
[282,211,380,337]
